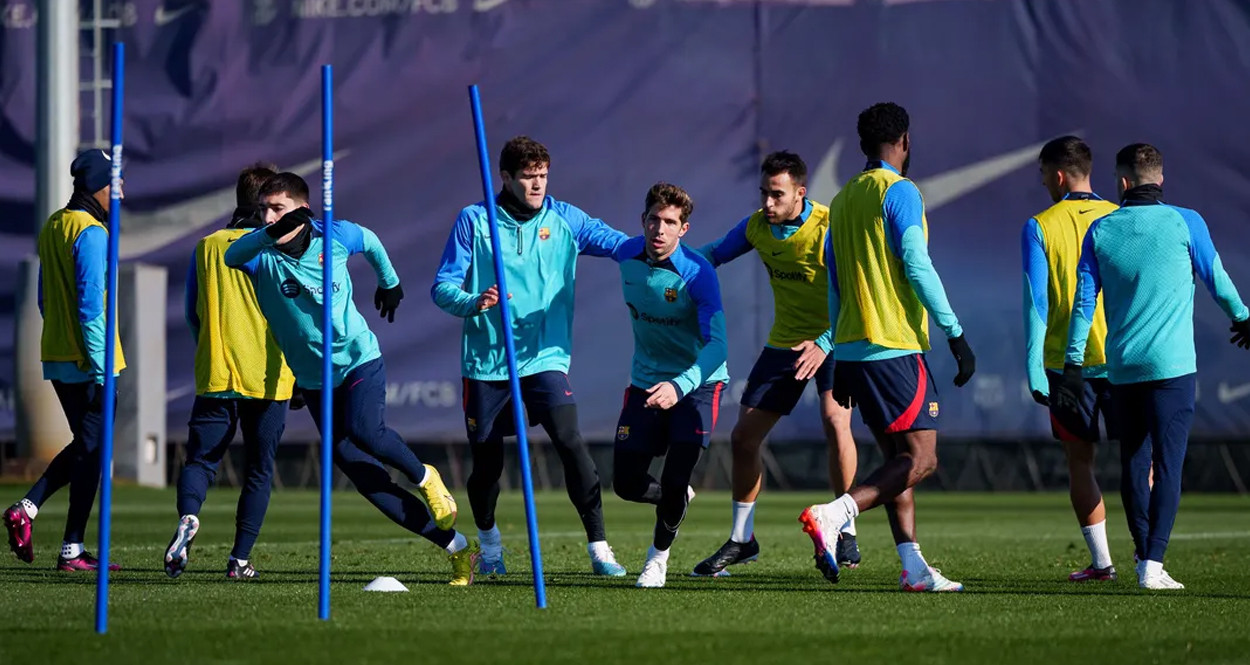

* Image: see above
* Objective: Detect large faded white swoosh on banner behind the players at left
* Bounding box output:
[118,150,350,260]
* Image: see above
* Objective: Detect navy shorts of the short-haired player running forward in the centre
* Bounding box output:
[616,383,725,458]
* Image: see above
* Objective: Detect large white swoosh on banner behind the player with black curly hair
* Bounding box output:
[808,131,1079,213]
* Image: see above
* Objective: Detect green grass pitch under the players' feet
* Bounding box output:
[0,486,1250,665]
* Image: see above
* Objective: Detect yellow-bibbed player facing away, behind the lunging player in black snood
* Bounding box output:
[165,164,295,580]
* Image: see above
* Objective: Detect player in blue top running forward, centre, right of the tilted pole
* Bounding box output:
[613,183,729,588]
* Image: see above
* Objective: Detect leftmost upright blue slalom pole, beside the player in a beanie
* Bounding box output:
[95,41,126,635]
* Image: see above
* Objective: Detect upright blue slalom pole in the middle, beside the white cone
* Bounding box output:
[322,65,334,621]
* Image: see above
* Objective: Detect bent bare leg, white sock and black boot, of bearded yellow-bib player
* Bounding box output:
[693,406,781,578]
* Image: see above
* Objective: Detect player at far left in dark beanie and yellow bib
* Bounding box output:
[4,150,126,571]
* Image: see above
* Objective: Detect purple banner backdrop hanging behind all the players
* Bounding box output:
[0,0,1250,440]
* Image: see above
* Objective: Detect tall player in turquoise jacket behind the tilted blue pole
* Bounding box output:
[430,136,628,578]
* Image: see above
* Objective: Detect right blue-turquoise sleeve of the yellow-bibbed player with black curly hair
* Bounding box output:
[883,180,964,339]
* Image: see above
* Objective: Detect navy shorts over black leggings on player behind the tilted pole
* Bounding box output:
[464,371,578,444]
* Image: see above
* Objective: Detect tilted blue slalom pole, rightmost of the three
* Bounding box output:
[469,85,546,610]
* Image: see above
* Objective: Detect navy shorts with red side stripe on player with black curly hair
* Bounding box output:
[834,354,940,434]
